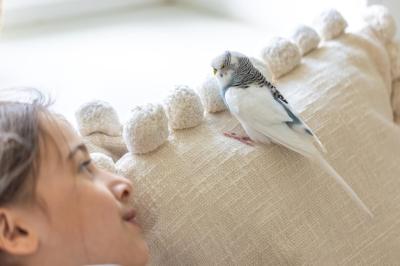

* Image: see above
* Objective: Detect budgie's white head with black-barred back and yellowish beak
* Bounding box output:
[211,51,246,90]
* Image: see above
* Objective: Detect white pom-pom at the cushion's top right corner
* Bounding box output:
[363,5,396,43]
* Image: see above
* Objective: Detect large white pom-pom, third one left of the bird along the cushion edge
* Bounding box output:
[122,104,169,154]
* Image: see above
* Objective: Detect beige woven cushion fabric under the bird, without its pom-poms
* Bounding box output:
[117,25,400,265]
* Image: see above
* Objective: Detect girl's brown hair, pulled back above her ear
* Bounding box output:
[0,89,50,206]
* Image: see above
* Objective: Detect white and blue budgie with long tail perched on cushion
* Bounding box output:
[211,51,373,217]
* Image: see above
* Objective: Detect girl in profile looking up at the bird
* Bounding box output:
[0,90,149,266]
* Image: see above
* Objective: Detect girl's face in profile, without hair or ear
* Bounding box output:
[21,116,149,266]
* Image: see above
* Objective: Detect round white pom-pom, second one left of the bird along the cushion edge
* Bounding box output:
[165,85,204,129]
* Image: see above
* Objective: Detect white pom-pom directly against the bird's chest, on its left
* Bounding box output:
[198,76,226,113]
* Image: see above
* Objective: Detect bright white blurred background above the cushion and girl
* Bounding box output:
[0,0,400,125]
